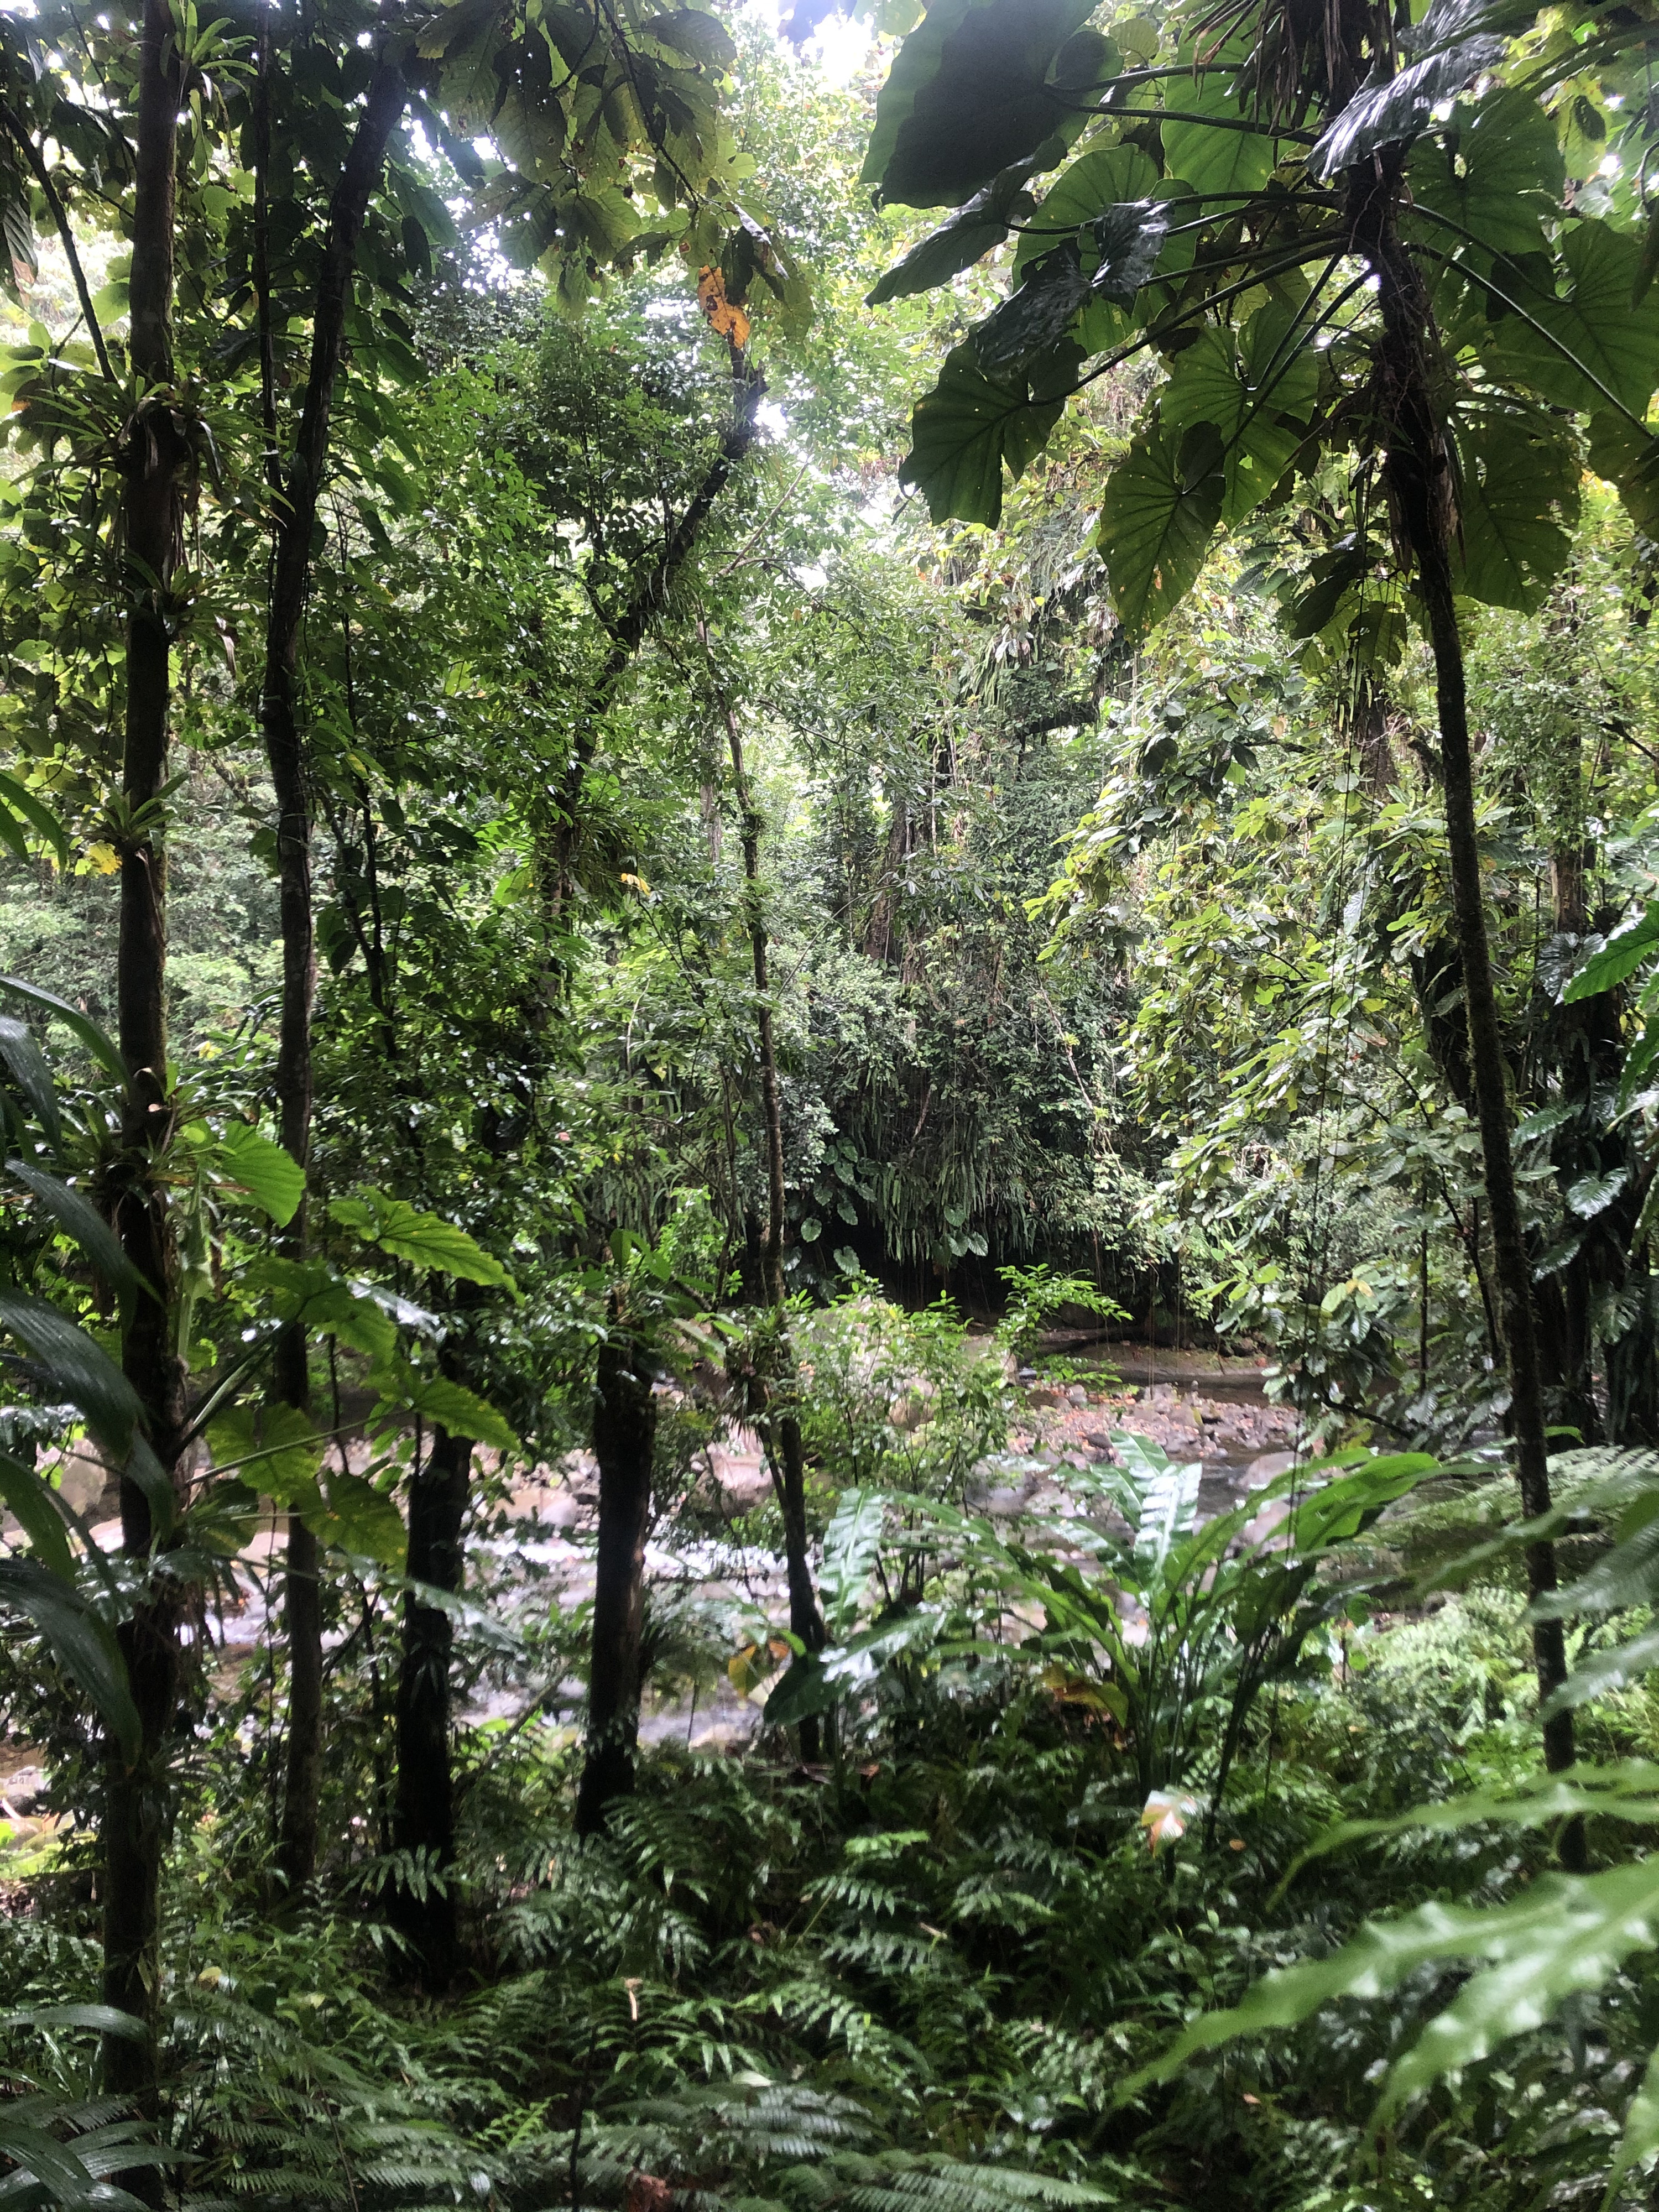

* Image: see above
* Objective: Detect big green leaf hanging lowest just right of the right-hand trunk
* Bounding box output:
[1455,414,1579,615]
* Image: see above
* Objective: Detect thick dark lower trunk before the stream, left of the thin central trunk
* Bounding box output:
[575,1301,657,1836]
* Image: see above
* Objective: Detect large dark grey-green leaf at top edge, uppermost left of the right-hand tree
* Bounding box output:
[863,0,1117,208]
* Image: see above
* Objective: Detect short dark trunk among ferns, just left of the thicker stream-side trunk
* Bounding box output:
[392,1429,473,1991]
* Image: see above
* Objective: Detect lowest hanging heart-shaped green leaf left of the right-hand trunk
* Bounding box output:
[1099,420,1228,637]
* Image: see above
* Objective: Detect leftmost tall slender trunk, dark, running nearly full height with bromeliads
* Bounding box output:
[104,0,188,2132]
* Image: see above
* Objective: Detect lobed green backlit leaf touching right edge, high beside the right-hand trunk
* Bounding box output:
[1484,221,1659,416]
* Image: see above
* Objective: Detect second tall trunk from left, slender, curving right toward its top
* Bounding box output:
[270,51,405,1893]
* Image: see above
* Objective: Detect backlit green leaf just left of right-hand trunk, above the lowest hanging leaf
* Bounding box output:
[1159,301,1318,522]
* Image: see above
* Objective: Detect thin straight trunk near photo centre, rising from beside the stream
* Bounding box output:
[726,681,823,1763]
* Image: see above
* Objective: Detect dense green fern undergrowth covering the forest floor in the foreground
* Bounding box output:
[0,1588,1659,2212]
